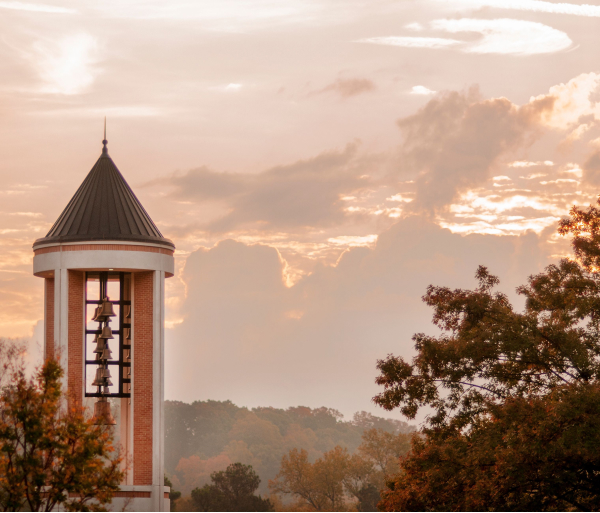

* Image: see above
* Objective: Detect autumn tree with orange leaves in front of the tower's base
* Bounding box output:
[0,360,123,511]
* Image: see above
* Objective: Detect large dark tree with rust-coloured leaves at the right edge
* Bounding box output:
[375,201,600,511]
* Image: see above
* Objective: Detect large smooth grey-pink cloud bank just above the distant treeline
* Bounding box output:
[166,216,547,415]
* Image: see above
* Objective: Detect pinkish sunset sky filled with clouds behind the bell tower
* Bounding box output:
[0,0,600,418]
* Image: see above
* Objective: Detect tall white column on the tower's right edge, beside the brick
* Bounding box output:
[152,271,165,511]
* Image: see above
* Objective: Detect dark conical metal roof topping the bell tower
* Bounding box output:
[33,140,175,249]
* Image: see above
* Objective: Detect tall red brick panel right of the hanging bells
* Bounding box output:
[133,271,154,485]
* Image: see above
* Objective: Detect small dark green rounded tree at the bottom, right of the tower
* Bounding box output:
[192,463,273,511]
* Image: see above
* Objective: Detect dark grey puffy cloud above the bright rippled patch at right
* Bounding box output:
[398,89,554,211]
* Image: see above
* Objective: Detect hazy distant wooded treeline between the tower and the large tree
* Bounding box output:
[165,401,415,496]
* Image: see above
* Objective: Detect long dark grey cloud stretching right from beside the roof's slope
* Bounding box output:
[155,144,376,233]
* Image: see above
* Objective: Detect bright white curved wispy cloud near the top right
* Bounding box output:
[431,18,572,55]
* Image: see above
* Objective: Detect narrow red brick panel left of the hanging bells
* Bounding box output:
[67,270,84,404]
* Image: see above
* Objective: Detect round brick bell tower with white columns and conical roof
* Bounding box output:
[33,133,175,511]
